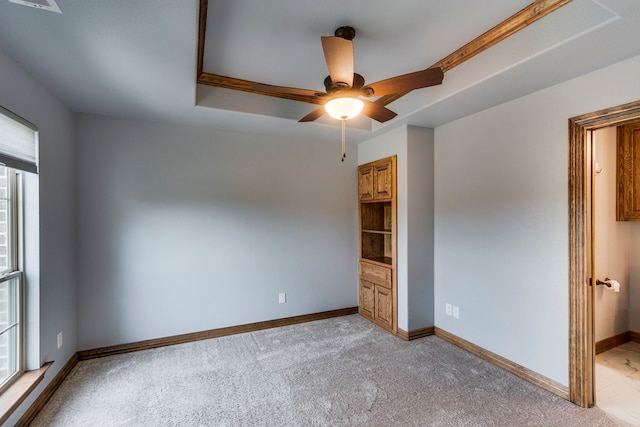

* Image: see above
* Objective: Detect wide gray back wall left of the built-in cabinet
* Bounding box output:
[77,115,358,349]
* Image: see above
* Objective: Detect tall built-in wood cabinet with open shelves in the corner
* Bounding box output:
[358,156,398,334]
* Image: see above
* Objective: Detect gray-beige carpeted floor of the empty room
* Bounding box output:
[32,315,625,427]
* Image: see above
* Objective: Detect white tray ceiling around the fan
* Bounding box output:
[0,0,640,142]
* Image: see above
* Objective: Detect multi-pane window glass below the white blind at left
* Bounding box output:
[0,165,23,389]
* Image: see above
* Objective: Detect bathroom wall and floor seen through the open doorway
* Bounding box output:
[588,126,640,425]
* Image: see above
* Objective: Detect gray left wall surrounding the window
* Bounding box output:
[0,44,76,425]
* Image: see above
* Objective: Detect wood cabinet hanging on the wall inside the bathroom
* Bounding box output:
[616,123,640,221]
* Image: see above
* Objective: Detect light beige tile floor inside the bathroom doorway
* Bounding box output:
[596,342,640,426]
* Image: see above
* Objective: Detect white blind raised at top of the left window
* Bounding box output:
[0,107,38,173]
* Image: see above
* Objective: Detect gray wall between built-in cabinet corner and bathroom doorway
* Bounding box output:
[435,57,640,385]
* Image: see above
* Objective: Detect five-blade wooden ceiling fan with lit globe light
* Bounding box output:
[251,27,444,122]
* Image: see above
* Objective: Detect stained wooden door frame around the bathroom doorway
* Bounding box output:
[569,101,640,408]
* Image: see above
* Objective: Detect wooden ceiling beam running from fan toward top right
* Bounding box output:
[376,0,572,105]
